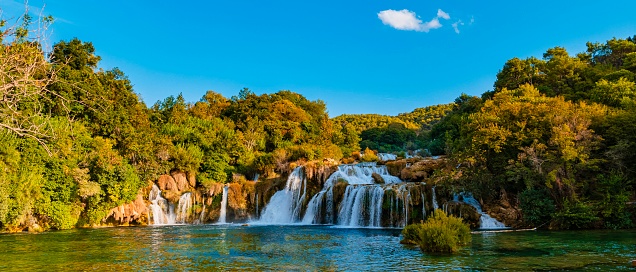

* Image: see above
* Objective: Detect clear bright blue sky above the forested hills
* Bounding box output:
[0,0,636,116]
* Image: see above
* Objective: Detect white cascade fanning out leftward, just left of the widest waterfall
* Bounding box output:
[259,166,307,224]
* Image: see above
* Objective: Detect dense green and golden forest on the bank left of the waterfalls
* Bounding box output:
[0,17,359,230]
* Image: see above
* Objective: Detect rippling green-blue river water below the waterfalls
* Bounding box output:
[0,225,636,271]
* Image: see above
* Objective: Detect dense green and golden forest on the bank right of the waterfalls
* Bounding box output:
[428,36,636,229]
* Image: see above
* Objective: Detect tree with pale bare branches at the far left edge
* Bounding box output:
[0,12,57,154]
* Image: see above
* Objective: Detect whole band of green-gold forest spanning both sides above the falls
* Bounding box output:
[0,11,636,231]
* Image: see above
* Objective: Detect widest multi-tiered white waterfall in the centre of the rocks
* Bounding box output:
[302,163,408,227]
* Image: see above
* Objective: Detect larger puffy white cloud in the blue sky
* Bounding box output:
[378,9,450,32]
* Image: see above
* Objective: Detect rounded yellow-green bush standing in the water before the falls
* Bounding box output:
[402,210,471,253]
